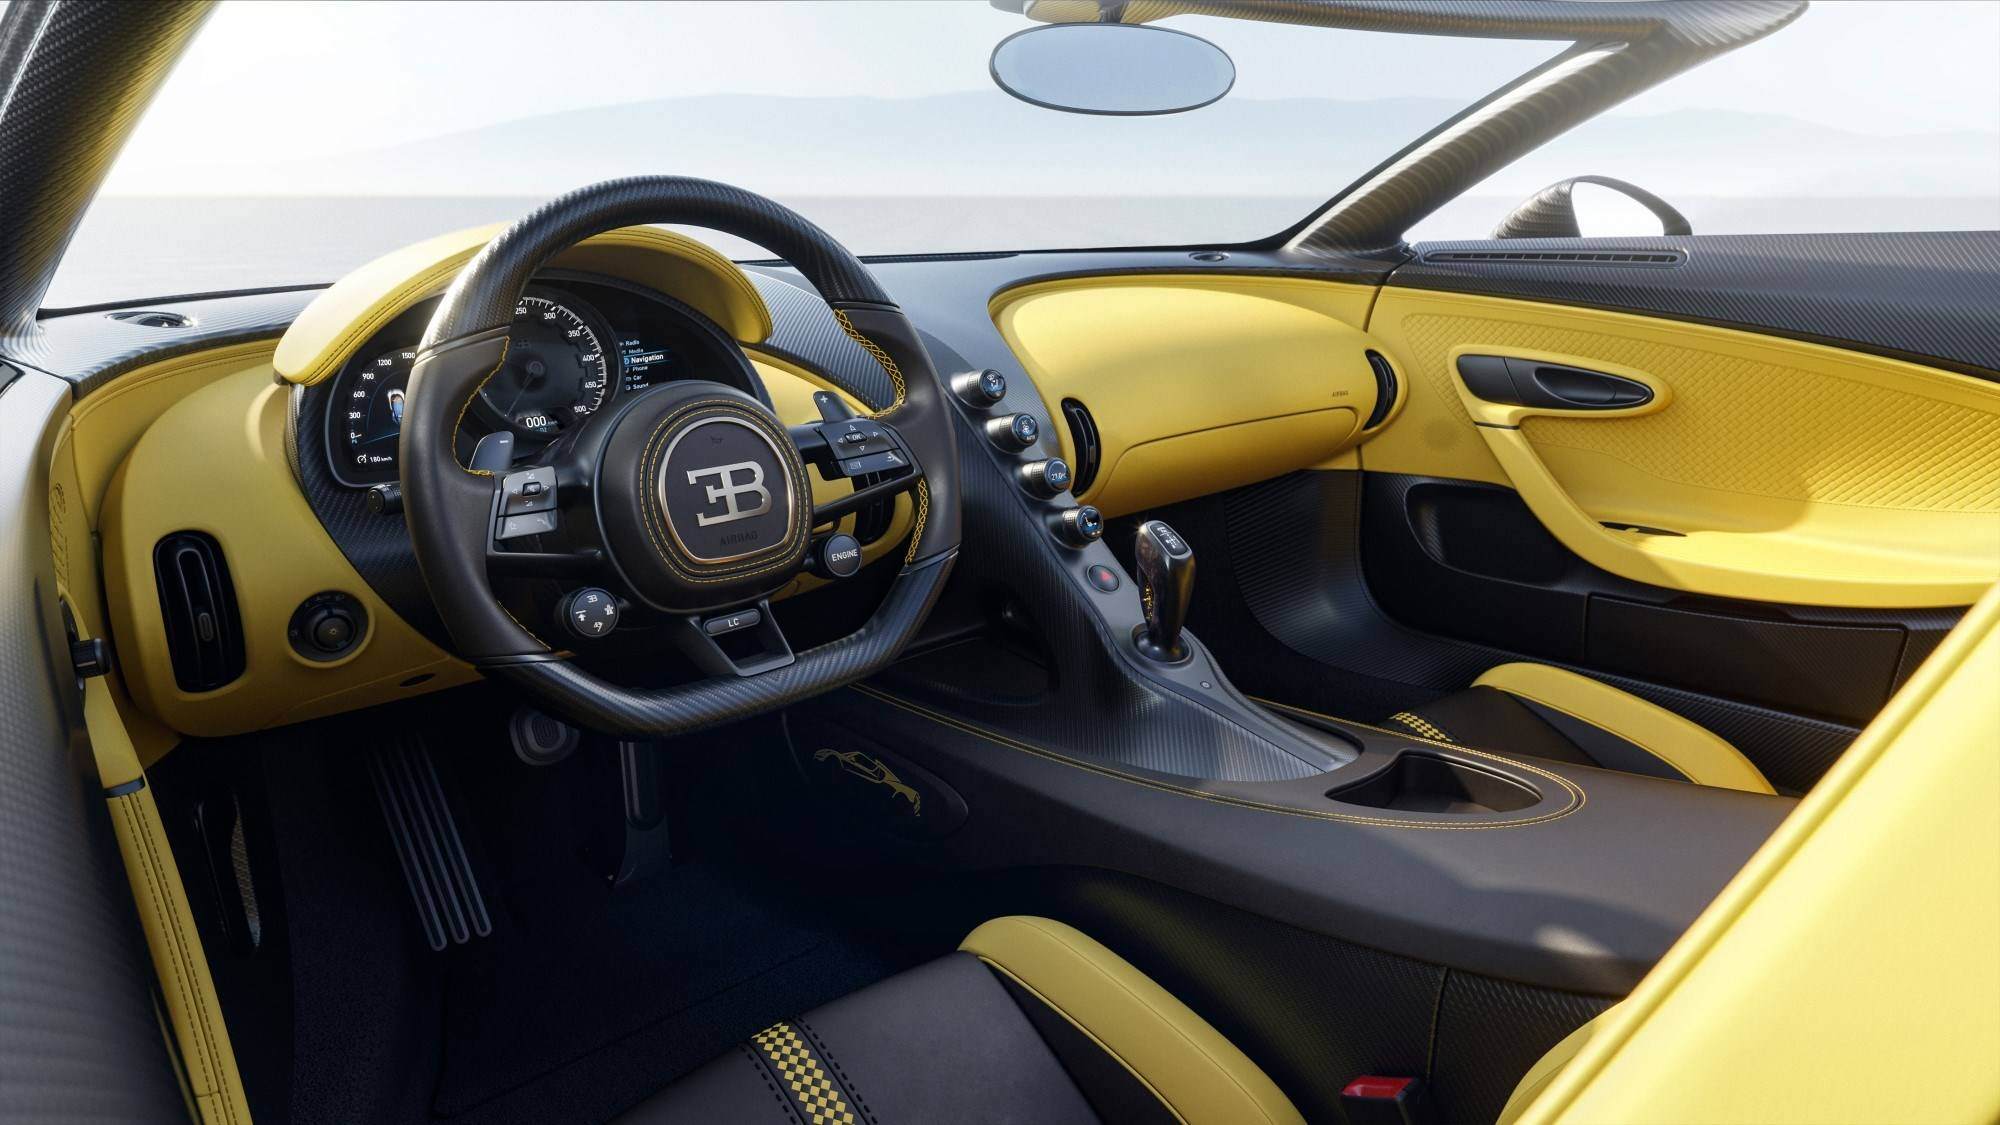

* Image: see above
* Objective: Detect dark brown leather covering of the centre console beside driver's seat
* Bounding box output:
[792,680,1794,984]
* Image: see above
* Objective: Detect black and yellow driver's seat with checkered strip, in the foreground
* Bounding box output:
[620,917,1592,1125]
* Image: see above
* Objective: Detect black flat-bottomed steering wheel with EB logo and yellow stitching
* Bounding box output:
[398,176,958,737]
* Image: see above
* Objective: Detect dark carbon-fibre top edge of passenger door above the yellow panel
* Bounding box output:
[1388,230,2000,380]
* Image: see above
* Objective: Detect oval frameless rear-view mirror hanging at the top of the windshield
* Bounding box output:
[988,24,1236,116]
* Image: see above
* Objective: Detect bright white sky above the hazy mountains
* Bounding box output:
[106,0,2000,194]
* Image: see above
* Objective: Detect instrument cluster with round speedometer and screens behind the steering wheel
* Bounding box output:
[322,272,768,488]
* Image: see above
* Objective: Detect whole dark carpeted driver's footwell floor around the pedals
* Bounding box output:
[162,689,962,1125]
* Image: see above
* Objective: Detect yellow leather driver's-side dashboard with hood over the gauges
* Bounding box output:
[68,228,912,736]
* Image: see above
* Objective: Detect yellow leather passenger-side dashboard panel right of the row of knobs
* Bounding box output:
[990,274,1380,516]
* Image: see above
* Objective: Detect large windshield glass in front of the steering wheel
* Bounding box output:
[44,0,1562,308]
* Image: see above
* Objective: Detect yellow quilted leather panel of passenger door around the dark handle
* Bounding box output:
[1362,288,2000,607]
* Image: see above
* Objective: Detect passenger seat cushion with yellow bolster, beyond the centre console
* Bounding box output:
[1382,663,1774,793]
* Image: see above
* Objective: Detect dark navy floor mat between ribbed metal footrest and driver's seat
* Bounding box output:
[416,704,948,1125]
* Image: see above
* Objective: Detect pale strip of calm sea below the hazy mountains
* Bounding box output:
[44,196,2000,308]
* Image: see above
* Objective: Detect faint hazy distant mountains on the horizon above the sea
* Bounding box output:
[176,90,2000,196]
